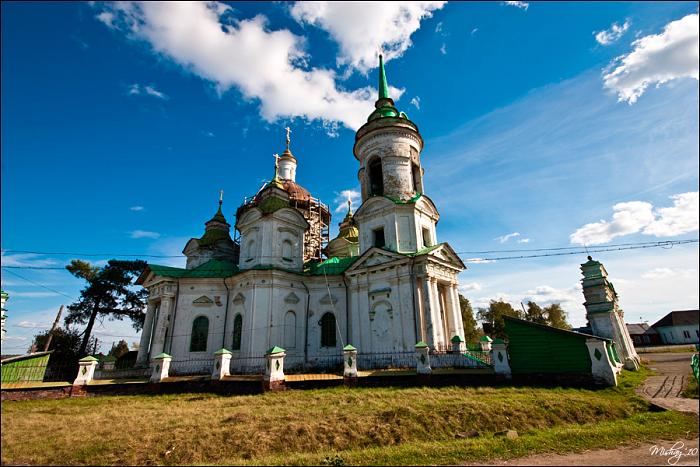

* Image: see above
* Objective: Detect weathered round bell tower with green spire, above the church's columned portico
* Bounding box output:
[353,55,439,254]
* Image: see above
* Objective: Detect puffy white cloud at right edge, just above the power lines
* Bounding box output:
[569,191,698,245]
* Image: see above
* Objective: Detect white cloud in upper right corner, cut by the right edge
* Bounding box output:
[603,14,698,104]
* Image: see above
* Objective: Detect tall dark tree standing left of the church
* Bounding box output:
[65,259,147,355]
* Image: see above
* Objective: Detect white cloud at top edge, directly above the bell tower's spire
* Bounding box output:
[291,1,447,73]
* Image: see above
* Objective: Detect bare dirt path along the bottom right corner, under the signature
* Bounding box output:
[474,438,698,466]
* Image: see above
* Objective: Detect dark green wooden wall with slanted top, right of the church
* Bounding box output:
[504,316,591,374]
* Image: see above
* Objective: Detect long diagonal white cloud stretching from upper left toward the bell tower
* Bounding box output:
[101,2,400,130]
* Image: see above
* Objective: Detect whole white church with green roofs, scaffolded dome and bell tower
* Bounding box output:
[137,57,465,371]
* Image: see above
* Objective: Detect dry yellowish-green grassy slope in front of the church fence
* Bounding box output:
[2,373,698,464]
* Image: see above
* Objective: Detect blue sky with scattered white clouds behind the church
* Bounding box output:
[1,2,698,353]
